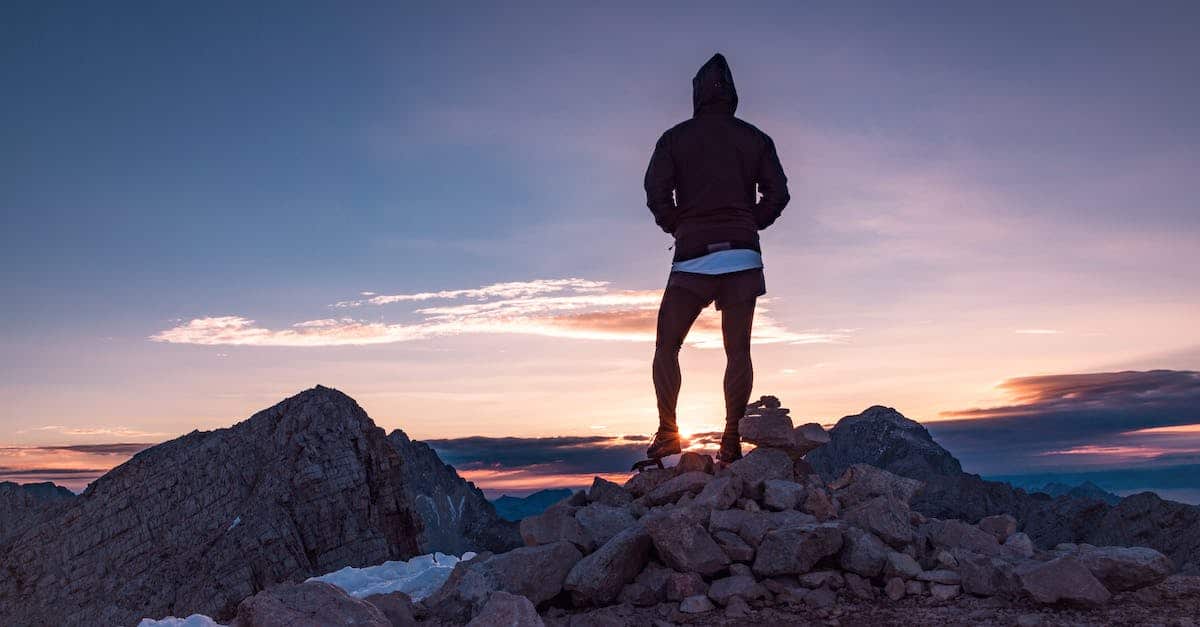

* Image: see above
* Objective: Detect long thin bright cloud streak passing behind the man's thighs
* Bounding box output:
[150,279,850,348]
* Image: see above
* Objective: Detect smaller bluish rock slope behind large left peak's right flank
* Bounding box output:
[388,429,521,555]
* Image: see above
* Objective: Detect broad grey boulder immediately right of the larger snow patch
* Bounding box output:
[424,538,585,622]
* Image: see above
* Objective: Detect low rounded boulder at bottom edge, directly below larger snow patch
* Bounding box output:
[232,581,391,627]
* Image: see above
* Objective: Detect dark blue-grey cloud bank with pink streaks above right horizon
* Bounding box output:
[926,370,1200,473]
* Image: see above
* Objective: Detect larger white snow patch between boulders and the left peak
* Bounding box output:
[307,553,475,601]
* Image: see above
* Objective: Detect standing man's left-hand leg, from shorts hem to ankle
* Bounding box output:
[652,286,705,431]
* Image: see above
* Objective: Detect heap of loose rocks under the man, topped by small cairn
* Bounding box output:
[418,396,1172,625]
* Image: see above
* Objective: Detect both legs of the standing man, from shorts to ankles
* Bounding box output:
[653,286,757,430]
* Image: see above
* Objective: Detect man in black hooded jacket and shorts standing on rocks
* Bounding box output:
[646,54,790,462]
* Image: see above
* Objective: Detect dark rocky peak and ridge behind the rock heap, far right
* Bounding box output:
[805,406,1200,574]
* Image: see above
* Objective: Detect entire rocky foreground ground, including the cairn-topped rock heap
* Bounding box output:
[220,398,1200,627]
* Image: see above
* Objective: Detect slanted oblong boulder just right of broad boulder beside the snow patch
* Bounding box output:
[559,525,650,605]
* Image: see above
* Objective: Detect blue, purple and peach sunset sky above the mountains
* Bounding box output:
[0,1,1200,500]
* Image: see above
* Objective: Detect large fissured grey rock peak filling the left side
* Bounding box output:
[0,386,503,625]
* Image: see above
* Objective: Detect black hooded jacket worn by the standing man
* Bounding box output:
[646,54,790,261]
